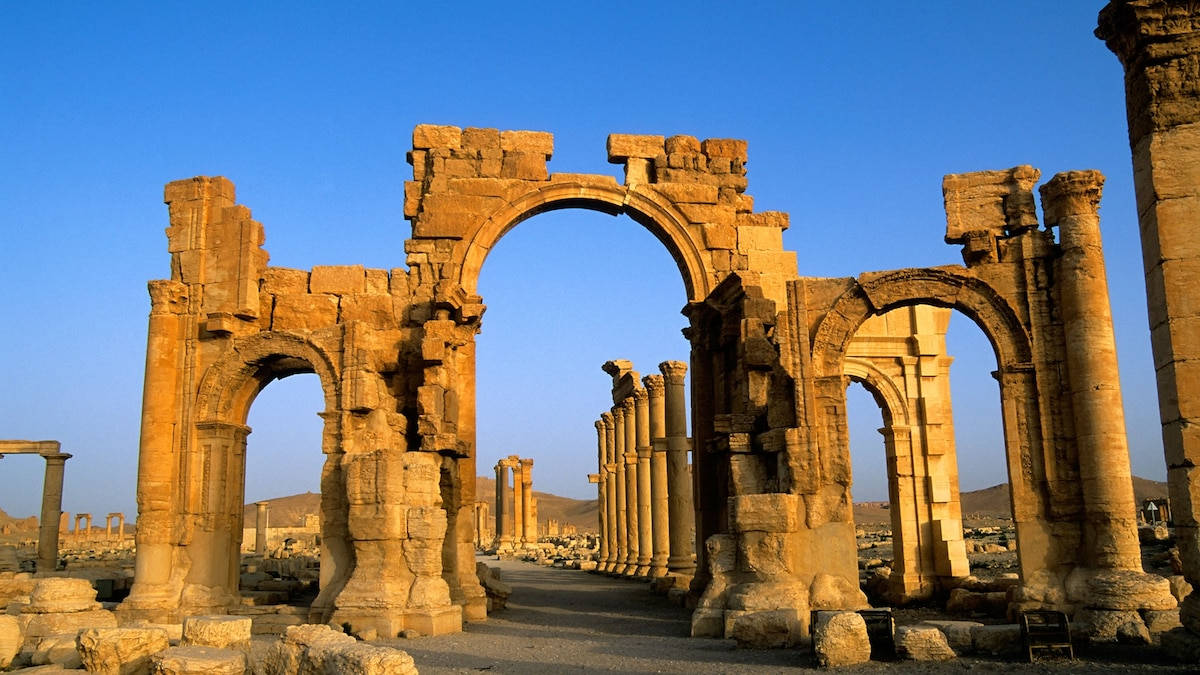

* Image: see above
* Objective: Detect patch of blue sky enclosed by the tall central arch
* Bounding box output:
[476,209,690,523]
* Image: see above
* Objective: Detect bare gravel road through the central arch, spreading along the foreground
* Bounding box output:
[385,557,1196,675]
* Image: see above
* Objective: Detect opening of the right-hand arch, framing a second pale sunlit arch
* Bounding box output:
[844,304,1016,609]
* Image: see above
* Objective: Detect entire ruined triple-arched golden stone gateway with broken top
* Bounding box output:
[119,125,1175,646]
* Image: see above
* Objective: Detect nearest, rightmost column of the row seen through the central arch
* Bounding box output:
[659,362,696,578]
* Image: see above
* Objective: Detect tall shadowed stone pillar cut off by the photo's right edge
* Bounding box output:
[1096,0,1200,633]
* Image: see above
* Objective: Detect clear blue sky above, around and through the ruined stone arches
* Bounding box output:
[0,1,1165,515]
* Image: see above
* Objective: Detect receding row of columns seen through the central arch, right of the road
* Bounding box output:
[588,362,696,584]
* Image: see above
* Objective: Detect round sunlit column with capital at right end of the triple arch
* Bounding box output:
[1040,171,1141,572]
